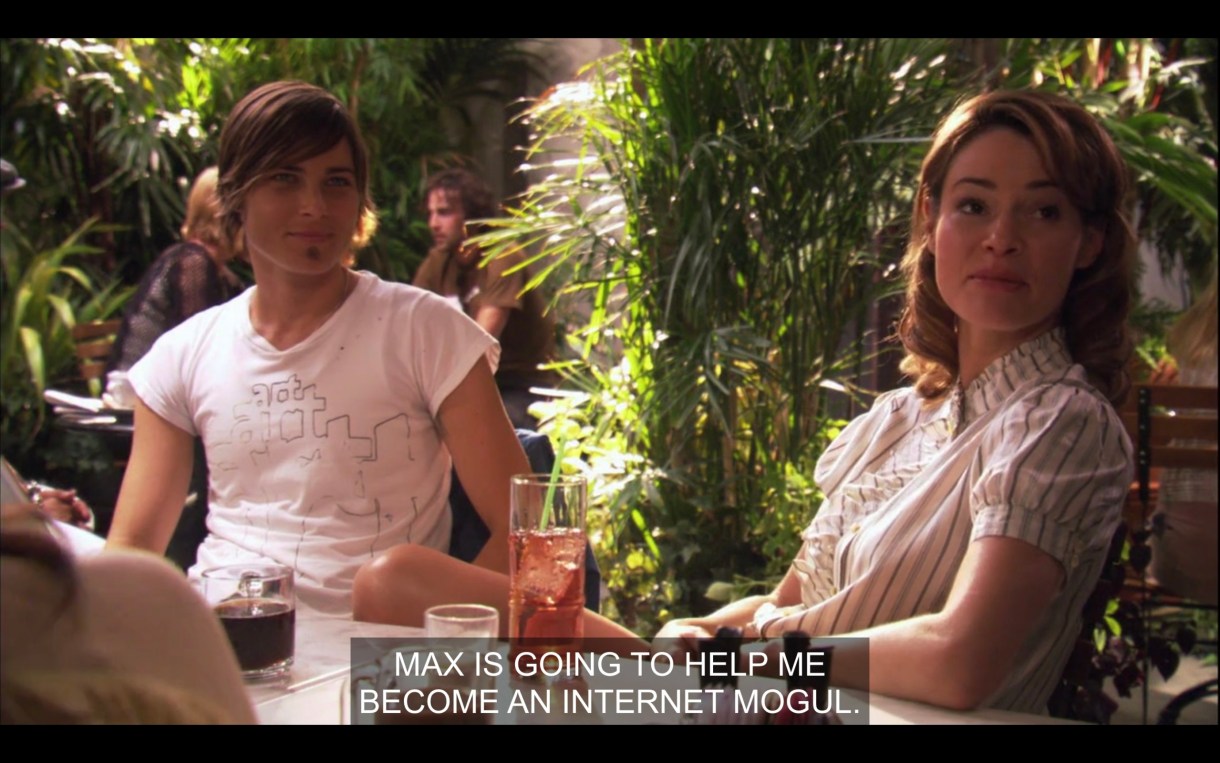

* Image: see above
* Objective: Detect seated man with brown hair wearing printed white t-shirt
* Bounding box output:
[109,82,528,614]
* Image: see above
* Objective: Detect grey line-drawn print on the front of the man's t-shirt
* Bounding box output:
[209,374,420,557]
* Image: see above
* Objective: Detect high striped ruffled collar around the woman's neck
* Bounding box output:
[935,327,1072,435]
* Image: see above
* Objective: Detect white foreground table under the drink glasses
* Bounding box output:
[248,617,1069,725]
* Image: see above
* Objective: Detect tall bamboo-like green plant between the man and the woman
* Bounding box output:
[484,39,947,622]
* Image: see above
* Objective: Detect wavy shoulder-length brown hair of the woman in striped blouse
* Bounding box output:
[898,90,1135,405]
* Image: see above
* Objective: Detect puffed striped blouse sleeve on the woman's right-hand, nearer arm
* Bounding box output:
[970,385,1132,570]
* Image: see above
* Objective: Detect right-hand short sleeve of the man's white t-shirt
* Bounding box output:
[409,288,500,418]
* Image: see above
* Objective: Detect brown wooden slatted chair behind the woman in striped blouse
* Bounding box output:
[1122,385,1220,724]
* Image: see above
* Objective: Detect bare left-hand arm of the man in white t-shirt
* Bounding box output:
[106,400,194,554]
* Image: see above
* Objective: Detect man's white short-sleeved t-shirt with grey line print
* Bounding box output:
[129,273,499,613]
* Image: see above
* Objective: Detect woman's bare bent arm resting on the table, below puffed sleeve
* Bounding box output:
[741,537,1064,709]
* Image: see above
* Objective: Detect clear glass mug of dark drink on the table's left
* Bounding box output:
[204,564,296,679]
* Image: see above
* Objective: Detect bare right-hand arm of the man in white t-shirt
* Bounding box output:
[437,359,529,574]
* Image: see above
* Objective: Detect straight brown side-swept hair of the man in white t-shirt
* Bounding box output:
[217,81,375,249]
